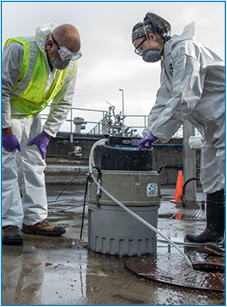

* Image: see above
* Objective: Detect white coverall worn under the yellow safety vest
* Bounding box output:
[2,23,76,228]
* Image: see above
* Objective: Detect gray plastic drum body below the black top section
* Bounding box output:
[88,171,159,256]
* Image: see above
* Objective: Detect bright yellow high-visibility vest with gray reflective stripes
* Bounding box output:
[5,37,76,118]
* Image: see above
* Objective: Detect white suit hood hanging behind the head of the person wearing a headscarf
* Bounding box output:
[165,21,195,55]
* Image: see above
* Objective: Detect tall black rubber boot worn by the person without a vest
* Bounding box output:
[185,190,225,243]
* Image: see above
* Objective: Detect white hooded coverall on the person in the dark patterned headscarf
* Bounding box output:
[143,22,225,193]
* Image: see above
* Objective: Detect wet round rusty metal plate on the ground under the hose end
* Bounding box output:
[126,253,225,292]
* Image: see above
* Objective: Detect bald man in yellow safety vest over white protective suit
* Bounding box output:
[2,23,82,244]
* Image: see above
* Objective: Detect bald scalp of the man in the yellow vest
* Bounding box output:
[53,24,80,52]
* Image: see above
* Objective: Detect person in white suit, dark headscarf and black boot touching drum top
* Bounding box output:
[132,12,225,256]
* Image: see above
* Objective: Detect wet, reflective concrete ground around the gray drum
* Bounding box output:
[2,184,225,305]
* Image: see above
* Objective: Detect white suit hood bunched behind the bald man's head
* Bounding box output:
[35,22,58,55]
